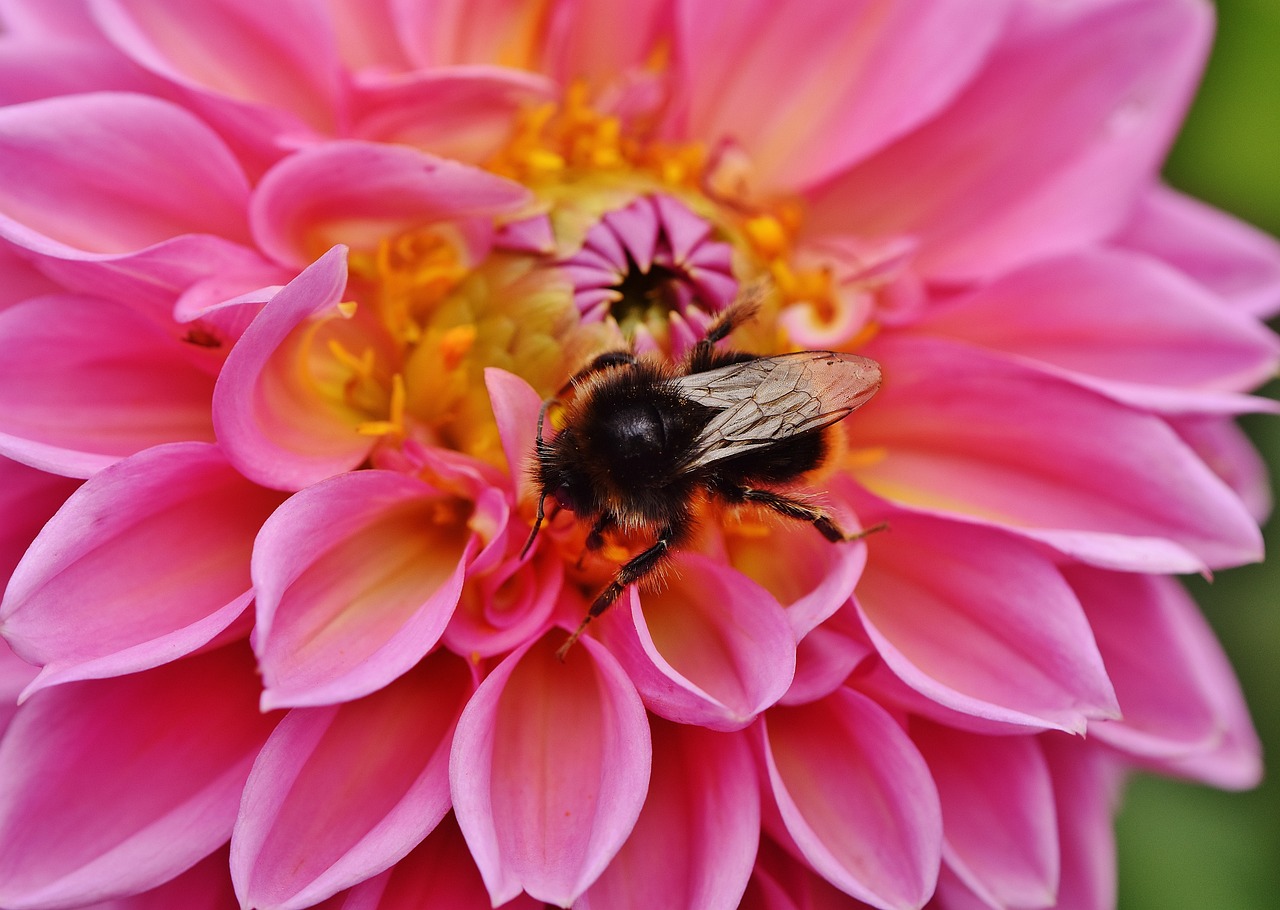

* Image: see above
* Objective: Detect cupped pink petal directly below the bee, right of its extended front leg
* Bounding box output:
[600,553,796,731]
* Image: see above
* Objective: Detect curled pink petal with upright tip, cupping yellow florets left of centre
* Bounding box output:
[214,247,372,490]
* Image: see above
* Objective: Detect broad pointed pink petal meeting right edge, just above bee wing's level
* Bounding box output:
[918,251,1280,410]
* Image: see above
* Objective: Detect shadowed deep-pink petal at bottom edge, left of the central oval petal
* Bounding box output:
[335,815,547,910]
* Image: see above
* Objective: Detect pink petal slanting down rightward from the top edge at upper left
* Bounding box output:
[93,0,340,132]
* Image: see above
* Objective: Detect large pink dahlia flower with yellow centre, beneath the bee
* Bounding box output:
[0,0,1280,910]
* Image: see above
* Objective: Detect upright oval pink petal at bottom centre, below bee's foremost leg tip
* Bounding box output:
[449,636,652,906]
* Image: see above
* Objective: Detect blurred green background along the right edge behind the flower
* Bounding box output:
[1119,0,1280,910]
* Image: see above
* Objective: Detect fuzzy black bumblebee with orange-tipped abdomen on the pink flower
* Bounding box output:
[521,303,881,659]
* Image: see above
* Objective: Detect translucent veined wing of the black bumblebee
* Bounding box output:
[673,351,881,470]
